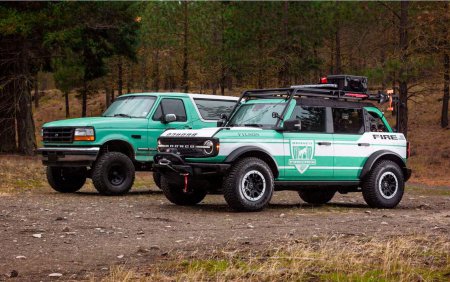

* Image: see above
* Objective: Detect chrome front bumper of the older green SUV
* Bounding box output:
[37,147,100,166]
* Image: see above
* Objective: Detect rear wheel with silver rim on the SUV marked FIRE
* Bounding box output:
[362,160,405,209]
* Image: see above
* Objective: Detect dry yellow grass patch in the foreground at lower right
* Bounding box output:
[104,236,450,282]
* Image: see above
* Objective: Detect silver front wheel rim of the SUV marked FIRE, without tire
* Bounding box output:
[239,170,266,202]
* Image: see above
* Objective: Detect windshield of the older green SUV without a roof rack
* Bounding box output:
[102,96,156,118]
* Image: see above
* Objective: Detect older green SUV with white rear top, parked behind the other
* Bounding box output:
[38,93,238,195]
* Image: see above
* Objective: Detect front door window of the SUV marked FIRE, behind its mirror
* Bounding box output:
[290,105,326,132]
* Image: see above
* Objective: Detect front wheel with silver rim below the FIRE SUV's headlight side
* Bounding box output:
[222,158,274,211]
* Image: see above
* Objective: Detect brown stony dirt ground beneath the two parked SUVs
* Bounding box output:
[0,175,450,281]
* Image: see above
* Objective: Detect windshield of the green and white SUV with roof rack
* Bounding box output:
[228,101,286,128]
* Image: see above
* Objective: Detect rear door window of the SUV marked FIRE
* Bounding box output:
[332,108,364,134]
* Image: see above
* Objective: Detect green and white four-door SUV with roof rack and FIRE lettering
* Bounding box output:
[154,76,411,211]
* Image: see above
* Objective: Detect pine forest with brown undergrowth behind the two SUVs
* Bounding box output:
[0,1,450,185]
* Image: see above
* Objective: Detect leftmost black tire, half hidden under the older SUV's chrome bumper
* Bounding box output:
[47,166,87,193]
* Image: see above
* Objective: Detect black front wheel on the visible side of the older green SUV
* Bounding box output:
[92,152,134,195]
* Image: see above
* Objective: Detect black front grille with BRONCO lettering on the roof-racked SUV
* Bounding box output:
[158,137,215,158]
